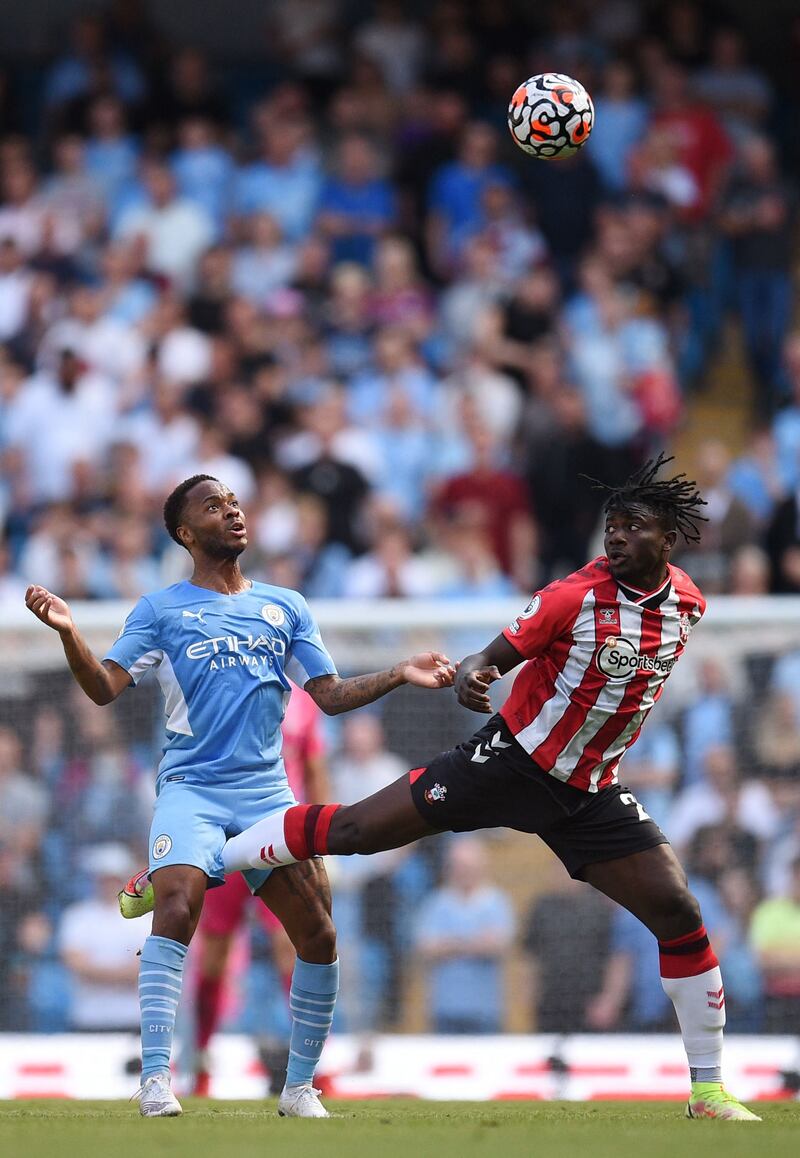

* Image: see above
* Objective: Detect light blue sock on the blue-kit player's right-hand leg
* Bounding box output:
[286,958,339,1085]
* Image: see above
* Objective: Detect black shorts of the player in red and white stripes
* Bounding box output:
[411,716,668,879]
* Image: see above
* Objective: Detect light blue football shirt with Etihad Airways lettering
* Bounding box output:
[105,580,336,790]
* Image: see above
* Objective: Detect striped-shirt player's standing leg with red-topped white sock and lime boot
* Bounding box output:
[584,844,761,1122]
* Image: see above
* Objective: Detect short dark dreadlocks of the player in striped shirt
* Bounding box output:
[581,453,709,543]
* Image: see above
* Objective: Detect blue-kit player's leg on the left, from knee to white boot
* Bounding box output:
[139,864,207,1117]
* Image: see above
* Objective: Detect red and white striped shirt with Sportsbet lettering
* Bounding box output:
[500,556,705,792]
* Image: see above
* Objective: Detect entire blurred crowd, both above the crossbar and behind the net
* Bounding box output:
[0,0,800,1032]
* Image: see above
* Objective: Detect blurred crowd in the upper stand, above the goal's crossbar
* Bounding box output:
[0,0,800,600]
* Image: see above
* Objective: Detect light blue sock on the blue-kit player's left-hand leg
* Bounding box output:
[139,937,188,1082]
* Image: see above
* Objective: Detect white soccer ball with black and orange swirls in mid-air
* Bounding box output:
[508,73,594,161]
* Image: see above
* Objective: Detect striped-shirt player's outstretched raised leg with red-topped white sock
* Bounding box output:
[222,769,441,870]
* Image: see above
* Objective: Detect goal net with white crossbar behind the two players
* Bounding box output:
[0,598,800,1036]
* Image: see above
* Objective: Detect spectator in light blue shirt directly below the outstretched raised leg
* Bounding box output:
[416,838,516,1033]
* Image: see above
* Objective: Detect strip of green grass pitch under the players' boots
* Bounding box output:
[0,1098,800,1158]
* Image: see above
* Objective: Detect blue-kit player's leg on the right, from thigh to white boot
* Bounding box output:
[257,859,339,1117]
